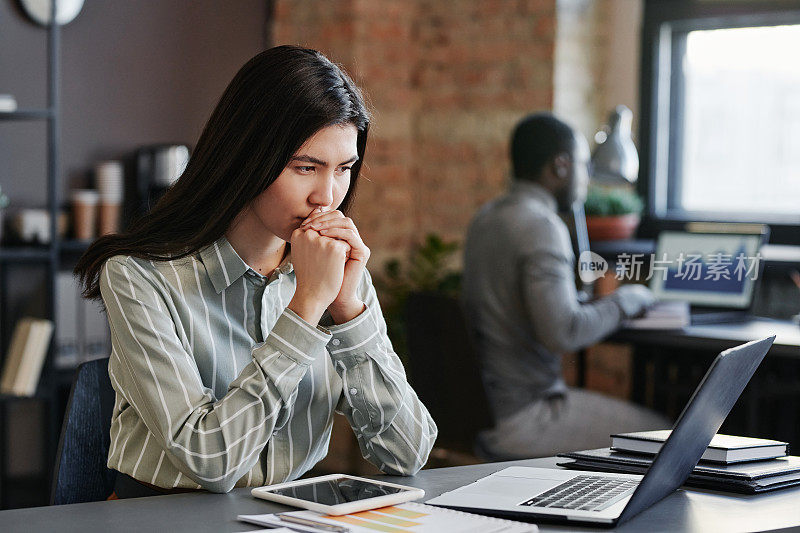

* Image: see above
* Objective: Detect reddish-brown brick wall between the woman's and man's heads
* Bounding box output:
[273,0,556,272]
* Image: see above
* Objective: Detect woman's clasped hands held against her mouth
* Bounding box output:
[289,208,370,324]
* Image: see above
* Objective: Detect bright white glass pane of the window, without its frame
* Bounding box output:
[673,24,800,217]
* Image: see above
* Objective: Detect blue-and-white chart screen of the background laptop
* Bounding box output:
[650,231,762,309]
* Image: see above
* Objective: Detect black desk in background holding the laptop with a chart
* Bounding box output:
[606,318,800,446]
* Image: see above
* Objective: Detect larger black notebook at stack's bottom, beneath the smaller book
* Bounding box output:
[558,448,800,494]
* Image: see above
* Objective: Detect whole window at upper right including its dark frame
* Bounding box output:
[640,0,800,244]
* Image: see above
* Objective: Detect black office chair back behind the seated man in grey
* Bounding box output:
[406,293,494,455]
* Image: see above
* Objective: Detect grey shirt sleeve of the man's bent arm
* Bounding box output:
[519,219,622,353]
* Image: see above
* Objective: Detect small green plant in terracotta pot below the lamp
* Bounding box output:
[584,185,643,241]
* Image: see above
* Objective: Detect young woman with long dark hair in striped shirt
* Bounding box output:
[75,46,436,492]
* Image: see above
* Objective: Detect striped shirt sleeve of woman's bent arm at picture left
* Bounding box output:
[100,257,330,492]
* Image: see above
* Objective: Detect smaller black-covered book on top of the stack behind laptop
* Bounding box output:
[611,429,789,464]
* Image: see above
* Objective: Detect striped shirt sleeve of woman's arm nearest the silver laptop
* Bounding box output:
[328,270,437,475]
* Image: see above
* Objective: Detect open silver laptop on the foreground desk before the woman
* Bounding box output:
[425,335,775,526]
